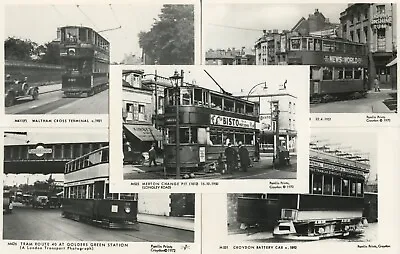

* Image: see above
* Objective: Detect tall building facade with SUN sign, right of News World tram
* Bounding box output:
[340,3,397,89]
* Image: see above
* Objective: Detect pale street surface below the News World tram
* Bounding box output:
[310,89,397,113]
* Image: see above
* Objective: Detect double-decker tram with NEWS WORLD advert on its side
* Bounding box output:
[287,36,368,103]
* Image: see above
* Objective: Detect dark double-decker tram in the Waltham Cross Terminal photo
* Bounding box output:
[58,26,110,96]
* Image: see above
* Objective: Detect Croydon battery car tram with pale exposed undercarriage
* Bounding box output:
[237,149,369,240]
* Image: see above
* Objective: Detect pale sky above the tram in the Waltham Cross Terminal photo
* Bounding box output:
[4,3,162,62]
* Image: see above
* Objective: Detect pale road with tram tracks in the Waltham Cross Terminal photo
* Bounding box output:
[5,84,108,114]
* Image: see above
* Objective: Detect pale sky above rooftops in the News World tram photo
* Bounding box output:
[203,3,347,50]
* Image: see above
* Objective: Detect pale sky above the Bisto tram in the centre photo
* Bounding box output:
[130,65,309,96]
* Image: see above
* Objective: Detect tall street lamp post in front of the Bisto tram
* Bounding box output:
[170,70,183,179]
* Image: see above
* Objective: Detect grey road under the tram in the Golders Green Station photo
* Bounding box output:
[3,203,194,242]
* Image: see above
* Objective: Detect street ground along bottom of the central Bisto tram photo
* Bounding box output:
[124,155,297,180]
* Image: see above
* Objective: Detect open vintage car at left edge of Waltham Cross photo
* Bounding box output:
[4,75,39,107]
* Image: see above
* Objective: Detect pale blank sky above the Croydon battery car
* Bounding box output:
[310,128,378,180]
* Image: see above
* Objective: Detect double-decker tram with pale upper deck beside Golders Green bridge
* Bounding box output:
[62,146,139,230]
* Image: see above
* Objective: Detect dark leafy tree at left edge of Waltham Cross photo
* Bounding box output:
[4,37,37,61]
